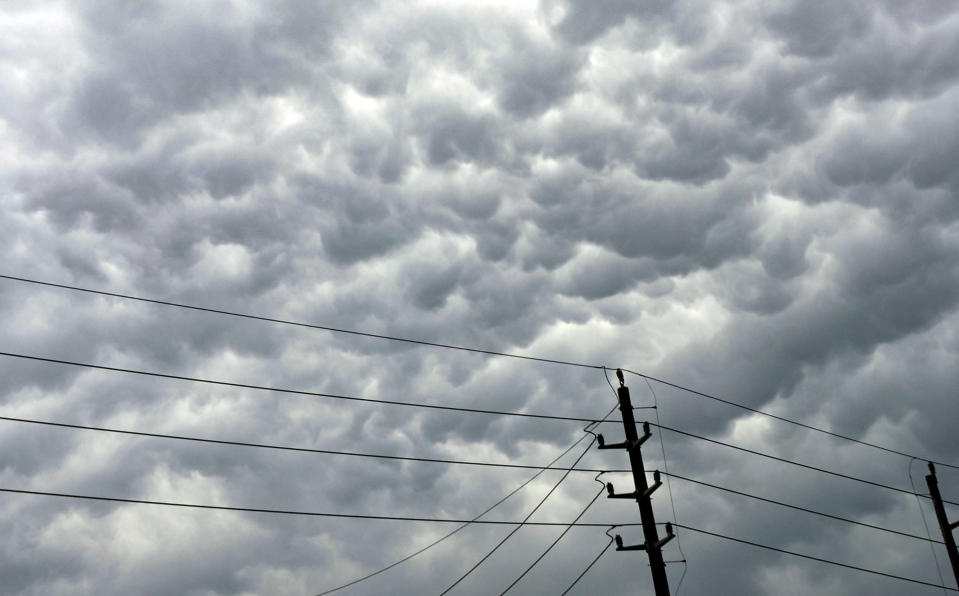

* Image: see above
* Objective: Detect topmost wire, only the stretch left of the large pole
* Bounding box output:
[0,274,602,368]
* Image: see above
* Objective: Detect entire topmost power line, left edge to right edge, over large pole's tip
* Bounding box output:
[0,274,959,469]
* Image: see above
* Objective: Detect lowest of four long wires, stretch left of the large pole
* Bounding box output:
[0,487,641,528]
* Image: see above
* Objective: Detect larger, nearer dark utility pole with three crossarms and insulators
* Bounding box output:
[597,369,673,596]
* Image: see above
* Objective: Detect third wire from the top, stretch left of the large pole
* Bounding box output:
[0,416,629,472]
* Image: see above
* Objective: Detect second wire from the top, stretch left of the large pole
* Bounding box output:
[0,352,598,423]
